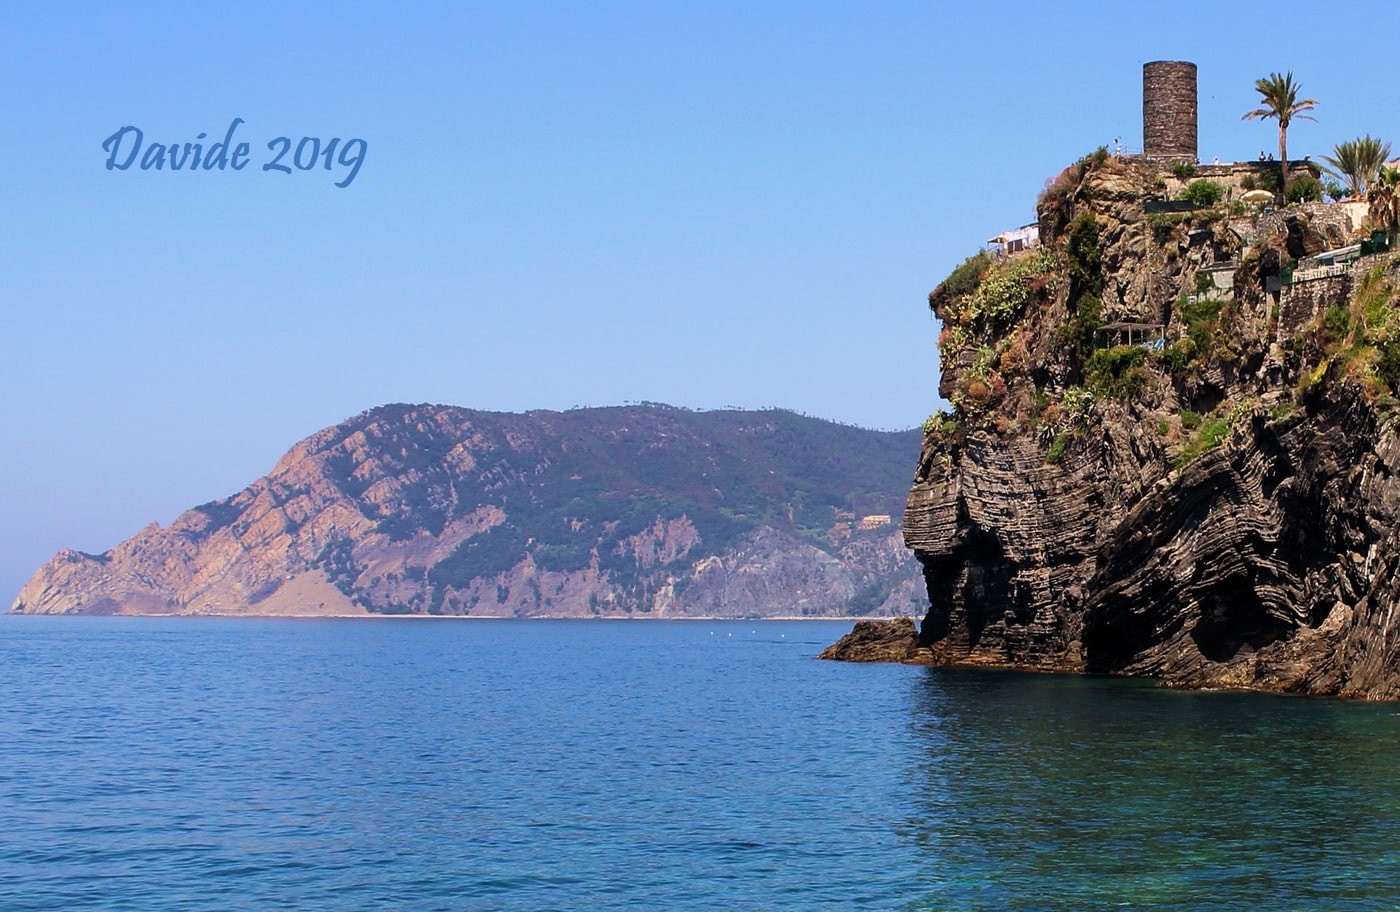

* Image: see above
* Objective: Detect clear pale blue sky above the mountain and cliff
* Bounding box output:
[0,0,1400,604]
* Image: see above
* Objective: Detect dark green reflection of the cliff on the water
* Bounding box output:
[904,670,1400,909]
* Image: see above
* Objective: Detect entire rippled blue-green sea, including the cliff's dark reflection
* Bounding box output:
[0,616,1400,912]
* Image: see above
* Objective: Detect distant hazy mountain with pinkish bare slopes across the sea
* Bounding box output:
[11,405,925,616]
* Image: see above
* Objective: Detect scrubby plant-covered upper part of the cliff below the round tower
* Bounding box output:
[927,150,1400,470]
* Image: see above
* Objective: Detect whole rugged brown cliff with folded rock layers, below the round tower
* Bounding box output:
[904,156,1400,699]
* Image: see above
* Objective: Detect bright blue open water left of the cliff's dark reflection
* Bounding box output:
[0,618,917,912]
